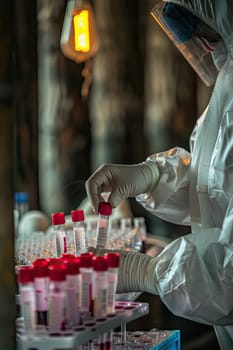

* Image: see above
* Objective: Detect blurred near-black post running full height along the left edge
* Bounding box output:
[0,0,16,350]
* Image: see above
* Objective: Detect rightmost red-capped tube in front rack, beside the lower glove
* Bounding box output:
[105,253,120,314]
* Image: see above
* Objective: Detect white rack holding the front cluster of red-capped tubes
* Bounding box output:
[16,301,149,350]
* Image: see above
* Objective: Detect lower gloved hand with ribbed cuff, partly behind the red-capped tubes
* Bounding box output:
[88,248,158,294]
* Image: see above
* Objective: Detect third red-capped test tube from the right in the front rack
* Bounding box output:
[79,252,93,317]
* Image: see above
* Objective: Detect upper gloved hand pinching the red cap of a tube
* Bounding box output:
[86,160,159,214]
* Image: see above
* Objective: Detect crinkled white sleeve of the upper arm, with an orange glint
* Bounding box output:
[136,147,191,225]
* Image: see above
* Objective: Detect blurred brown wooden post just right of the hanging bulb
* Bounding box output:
[90,0,145,170]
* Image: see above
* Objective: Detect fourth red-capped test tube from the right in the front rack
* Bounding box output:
[62,257,81,327]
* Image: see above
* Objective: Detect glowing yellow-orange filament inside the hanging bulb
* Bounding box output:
[73,10,90,52]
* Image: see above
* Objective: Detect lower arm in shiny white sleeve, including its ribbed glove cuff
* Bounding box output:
[118,200,233,326]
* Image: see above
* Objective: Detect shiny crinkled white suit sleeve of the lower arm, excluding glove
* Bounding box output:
[148,217,233,325]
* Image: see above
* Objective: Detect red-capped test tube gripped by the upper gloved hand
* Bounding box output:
[96,202,112,248]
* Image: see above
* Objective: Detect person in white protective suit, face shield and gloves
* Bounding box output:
[86,0,233,350]
